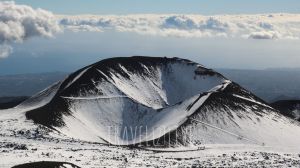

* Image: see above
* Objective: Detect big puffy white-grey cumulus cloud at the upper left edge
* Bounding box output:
[0,1,60,58]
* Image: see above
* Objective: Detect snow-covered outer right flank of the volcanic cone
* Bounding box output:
[180,88,300,146]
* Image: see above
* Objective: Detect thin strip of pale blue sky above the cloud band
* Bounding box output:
[16,0,300,15]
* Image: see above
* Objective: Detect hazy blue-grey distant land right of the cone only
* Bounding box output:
[217,68,300,103]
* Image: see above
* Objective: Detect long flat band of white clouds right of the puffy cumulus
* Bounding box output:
[58,14,300,39]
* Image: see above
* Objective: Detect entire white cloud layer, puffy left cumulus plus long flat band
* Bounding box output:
[0,1,300,58]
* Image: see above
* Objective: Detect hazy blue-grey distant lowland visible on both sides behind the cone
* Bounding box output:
[0,69,300,102]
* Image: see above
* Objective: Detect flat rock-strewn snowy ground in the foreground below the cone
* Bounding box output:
[0,136,300,168]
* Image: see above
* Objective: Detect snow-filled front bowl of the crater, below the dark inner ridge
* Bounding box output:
[56,90,213,145]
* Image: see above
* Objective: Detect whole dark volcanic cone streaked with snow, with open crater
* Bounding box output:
[22,57,300,145]
